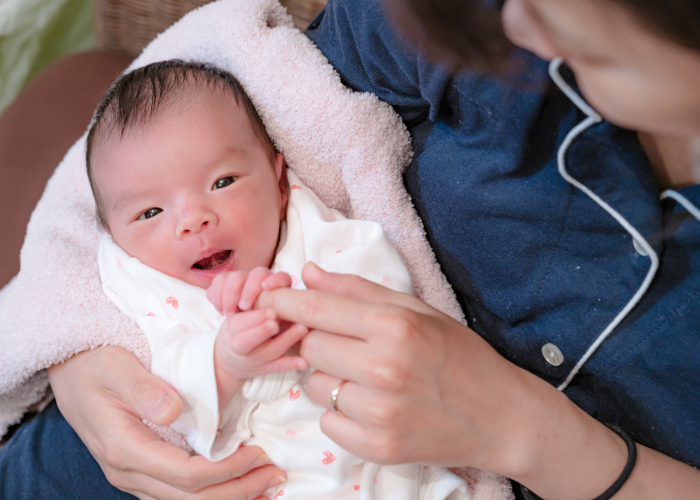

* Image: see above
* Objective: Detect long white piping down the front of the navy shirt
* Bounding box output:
[549,57,660,391]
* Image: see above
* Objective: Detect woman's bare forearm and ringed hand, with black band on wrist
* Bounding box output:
[258,265,700,500]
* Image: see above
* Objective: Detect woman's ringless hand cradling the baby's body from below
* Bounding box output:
[49,347,285,500]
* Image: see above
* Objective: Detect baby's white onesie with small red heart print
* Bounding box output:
[98,169,471,500]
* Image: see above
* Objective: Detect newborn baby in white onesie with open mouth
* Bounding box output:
[86,60,469,500]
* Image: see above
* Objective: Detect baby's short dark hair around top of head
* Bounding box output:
[85,59,277,228]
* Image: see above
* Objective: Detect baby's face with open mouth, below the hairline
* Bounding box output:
[93,91,287,288]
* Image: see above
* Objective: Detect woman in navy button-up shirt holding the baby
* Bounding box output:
[1,0,700,499]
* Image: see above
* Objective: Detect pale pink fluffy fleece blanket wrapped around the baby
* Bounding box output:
[0,0,512,500]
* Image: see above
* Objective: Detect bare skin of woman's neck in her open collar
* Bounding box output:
[638,132,700,191]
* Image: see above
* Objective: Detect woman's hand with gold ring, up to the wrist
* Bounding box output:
[257,265,518,470]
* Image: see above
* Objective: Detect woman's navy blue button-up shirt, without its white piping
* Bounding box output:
[307,0,700,467]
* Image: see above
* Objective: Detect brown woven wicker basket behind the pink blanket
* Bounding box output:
[95,0,327,55]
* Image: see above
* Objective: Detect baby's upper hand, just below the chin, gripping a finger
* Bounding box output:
[207,267,292,316]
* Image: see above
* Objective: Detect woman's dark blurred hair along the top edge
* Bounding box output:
[384,0,700,71]
